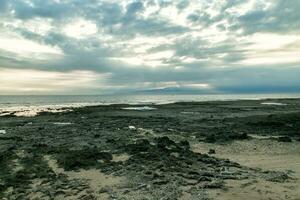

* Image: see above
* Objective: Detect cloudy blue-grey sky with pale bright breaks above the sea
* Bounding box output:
[0,0,300,95]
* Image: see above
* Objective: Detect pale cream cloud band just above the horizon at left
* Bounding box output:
[0,68,110,94]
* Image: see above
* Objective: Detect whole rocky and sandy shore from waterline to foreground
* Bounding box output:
[0,98,300,200]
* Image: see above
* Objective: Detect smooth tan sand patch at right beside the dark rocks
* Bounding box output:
[193,137,300,200]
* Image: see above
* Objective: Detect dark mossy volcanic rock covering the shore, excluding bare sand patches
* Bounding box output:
[0,100,300,200]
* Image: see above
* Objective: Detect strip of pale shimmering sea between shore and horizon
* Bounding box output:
[0,93,300,116]
